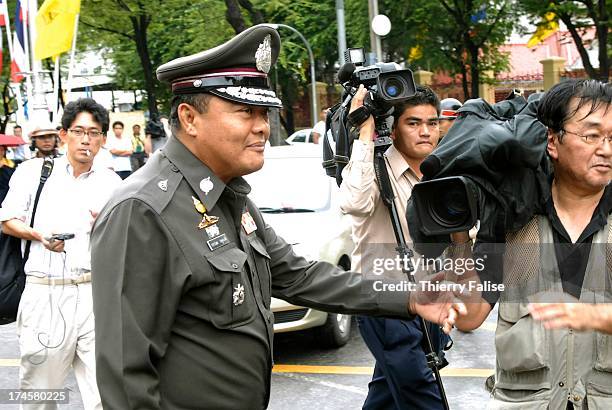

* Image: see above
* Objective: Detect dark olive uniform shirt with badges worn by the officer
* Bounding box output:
[91,137,410,409]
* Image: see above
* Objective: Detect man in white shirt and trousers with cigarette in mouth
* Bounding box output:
[0,99,121,409]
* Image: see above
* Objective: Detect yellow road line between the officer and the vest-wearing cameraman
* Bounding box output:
[272,364,494,378]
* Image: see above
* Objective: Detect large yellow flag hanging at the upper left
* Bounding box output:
[34,0,81,60]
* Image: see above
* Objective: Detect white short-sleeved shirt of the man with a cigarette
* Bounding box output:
[0,156,121,277]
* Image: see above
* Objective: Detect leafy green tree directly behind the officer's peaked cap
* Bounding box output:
[76,0,229,114]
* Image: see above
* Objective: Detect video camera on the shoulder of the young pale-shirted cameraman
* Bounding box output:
[323,48,416,186]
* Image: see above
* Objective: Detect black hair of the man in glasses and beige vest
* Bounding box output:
[538,78,612,140]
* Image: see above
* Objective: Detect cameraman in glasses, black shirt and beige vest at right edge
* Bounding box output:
[450,79,612,409]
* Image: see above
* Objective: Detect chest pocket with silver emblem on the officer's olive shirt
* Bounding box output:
[207,248,255,329]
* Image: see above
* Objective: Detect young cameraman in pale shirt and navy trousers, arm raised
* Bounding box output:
[340,85,448,409]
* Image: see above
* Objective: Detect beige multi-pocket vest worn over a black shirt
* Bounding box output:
[489,216,612,410]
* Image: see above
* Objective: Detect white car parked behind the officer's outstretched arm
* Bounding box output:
[246,144,354,347]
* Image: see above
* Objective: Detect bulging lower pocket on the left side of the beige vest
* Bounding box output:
[495,302,551,391]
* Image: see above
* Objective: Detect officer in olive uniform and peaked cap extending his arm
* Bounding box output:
[92,25,464,409]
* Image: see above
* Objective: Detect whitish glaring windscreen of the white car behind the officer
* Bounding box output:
[247,157,332,211]
